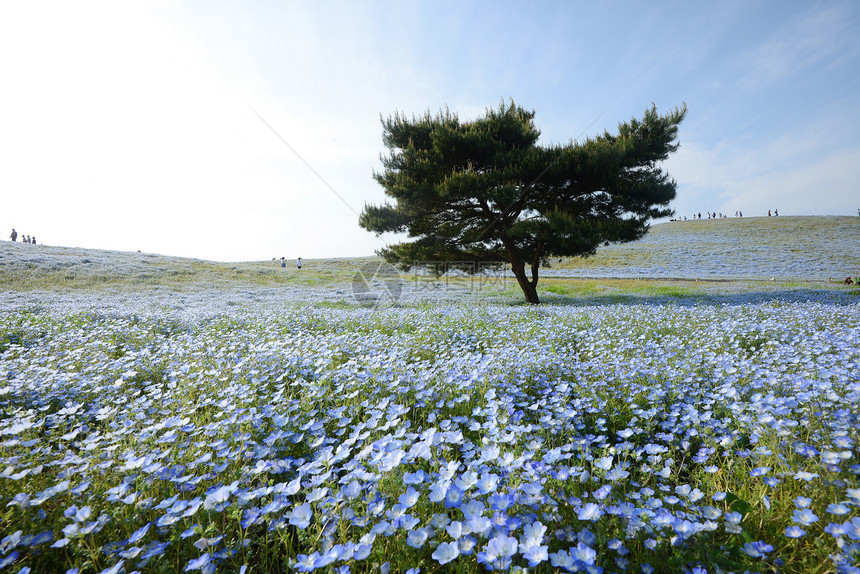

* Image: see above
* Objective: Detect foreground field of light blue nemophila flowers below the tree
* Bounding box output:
[0,291,860,573]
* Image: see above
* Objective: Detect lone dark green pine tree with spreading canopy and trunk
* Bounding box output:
[359,101,687,303]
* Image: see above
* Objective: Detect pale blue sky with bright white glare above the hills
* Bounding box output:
[0,0,860,261]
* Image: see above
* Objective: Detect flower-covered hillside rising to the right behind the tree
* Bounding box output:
[542,216,860,281]
